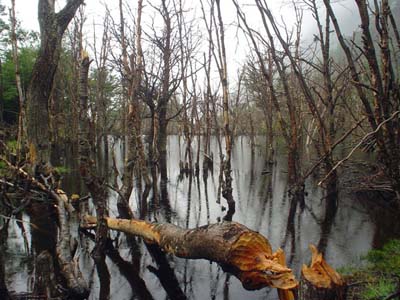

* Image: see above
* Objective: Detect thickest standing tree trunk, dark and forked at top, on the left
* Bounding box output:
[27,0,83,167]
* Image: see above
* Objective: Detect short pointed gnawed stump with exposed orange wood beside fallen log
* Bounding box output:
[299,245,346,300]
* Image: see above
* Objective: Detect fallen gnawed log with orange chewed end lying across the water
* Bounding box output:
[82,216,298,290]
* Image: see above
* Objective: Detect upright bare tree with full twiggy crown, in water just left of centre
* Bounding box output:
[142,0,188,202]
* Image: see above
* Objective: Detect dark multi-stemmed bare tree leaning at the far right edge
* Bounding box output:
[324,0,400,210]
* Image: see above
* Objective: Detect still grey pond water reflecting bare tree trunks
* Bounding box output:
[5,136,377,300]
